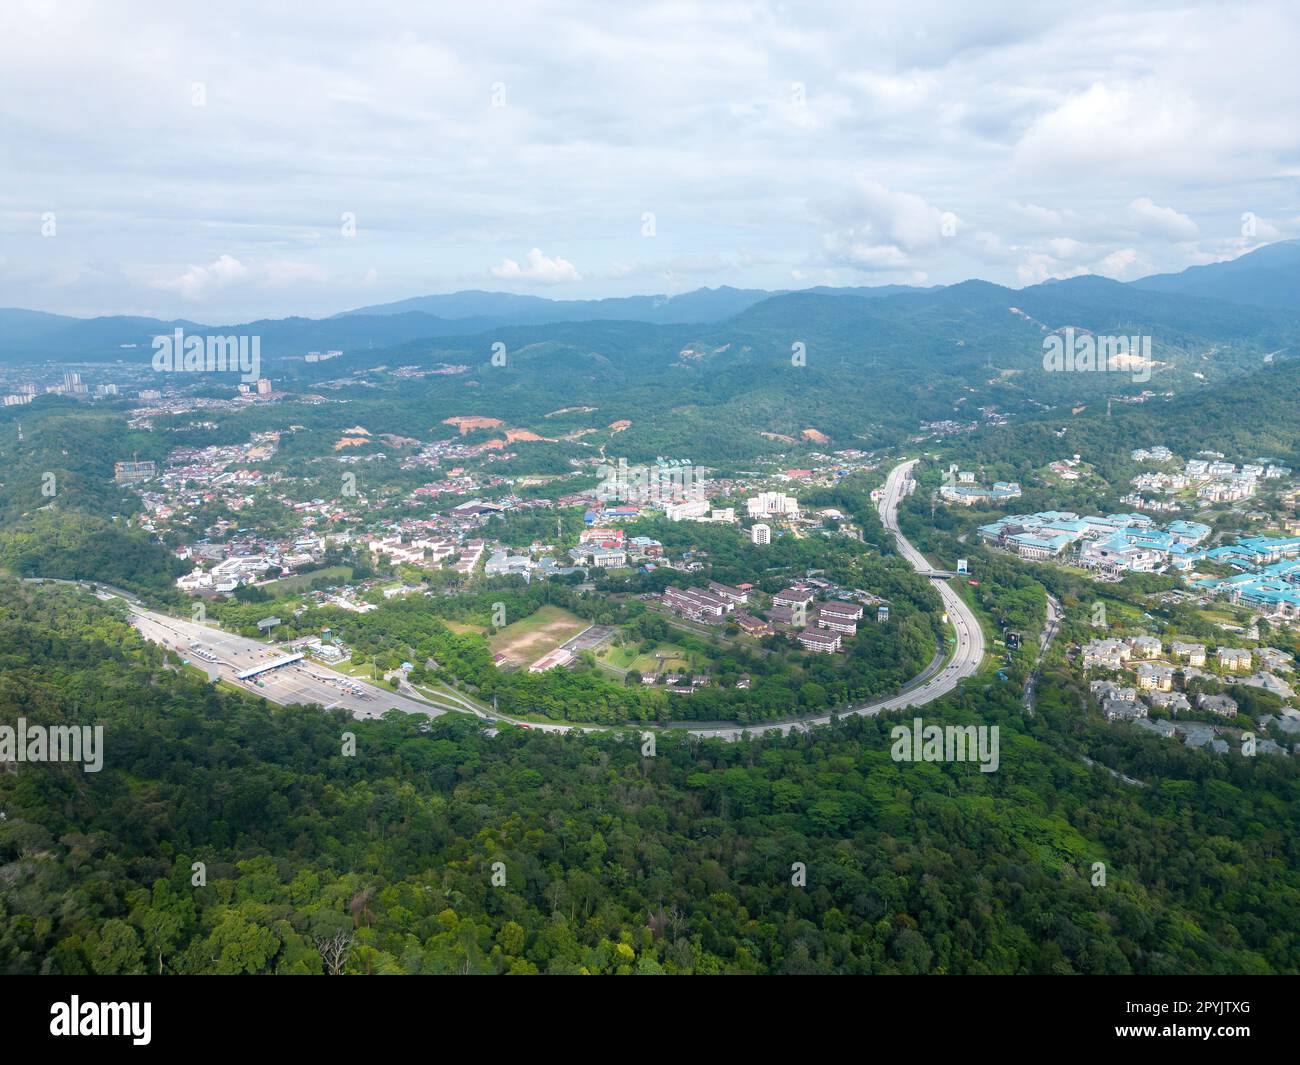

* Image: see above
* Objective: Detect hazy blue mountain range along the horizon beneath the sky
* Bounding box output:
[0,241,1300,363]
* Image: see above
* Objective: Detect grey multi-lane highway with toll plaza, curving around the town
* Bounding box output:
[38,459,984,740]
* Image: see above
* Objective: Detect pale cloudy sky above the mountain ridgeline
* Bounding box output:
[0,0,1300,322]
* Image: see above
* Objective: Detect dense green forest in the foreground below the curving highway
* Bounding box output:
[0,584,1300,974]
